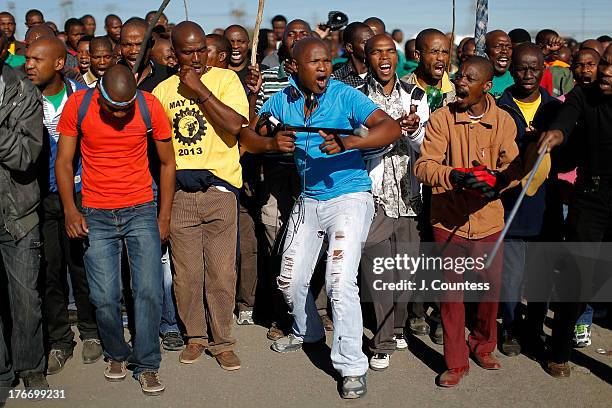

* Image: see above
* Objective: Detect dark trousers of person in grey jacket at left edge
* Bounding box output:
[0,227,45,386]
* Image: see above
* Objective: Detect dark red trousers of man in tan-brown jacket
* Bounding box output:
[434,228,504,369]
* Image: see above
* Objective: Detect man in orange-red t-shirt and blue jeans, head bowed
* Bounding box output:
[55,65,176,395]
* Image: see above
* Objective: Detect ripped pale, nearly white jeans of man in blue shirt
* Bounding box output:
[277,192,374,377]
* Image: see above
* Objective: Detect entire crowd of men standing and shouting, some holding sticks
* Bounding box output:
[0,5,612,398]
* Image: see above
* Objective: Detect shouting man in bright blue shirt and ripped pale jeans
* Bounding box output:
[240,38,401,398]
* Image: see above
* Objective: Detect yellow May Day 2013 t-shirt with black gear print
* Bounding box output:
[153,68,249,188]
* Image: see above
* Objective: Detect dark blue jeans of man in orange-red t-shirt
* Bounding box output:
[83,202,162,378]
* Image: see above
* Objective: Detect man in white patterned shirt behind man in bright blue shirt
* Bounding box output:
[358,34,429,370]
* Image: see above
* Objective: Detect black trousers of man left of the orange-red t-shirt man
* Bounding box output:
[41,193,98,350]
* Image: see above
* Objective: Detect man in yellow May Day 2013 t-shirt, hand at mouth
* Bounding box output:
[153,21,249,370]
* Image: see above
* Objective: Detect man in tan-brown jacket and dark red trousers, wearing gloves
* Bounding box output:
[415,57,521,387]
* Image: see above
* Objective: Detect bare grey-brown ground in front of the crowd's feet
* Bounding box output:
[6,318,612,408]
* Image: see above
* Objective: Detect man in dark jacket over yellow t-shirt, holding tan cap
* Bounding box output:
[497,43,561,364]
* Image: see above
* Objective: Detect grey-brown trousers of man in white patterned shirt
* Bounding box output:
[360,210,419,354]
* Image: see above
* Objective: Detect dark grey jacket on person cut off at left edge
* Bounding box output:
[0,64,43,241]
